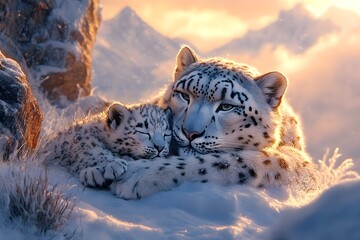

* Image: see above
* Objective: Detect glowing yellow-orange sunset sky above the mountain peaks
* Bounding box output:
[100,0,360,51]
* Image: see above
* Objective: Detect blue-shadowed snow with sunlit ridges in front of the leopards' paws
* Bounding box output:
[43,168,310,239]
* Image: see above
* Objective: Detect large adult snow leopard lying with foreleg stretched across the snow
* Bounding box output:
[110,46,317,199]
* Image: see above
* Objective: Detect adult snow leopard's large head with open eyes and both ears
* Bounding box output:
[163,46,287,155]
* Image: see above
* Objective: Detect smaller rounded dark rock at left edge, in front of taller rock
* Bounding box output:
[0,52,43,159]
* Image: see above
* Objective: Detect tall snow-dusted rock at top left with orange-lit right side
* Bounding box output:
[0,0,100,103]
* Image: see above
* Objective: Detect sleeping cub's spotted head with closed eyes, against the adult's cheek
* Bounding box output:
[106,103,171,159]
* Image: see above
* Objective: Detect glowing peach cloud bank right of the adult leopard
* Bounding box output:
[285,28,360,160]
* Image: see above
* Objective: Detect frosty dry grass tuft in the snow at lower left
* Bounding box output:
[0,163,75,235]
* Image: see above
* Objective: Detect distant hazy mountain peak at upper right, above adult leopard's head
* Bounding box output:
[209,5,338,56]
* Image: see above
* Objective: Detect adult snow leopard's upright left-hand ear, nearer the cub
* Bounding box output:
[174,45,199,81]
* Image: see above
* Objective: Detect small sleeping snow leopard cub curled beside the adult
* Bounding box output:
[40,103,171,187]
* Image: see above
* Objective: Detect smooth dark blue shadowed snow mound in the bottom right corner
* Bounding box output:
[264,182,360,240]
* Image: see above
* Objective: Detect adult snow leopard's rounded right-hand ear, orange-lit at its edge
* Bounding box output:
[254,72,287,109]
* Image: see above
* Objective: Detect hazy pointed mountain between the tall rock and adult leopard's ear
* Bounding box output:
[93,7,187,103]
